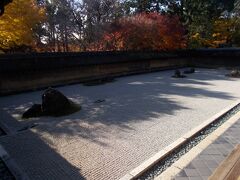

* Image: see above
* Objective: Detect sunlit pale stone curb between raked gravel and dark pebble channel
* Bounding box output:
[120,101,240,180]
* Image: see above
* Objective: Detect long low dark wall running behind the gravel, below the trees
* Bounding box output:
[0,49,240,95]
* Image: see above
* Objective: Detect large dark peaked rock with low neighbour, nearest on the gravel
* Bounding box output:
[22,88,81,118]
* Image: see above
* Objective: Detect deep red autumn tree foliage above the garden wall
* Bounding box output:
[89,13,186,51]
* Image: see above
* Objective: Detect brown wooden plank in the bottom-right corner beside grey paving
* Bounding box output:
[208,145,240,180]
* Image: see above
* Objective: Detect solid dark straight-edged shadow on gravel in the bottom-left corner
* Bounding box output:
[0,110,84,180]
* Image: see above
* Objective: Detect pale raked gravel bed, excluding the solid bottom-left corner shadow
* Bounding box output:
[0,69,240,179]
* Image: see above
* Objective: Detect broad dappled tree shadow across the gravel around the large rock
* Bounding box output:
[0,69,236,146]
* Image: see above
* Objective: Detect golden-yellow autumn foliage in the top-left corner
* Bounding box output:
[0,0,44,50]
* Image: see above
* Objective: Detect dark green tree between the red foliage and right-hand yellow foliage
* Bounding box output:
[167,0,234,47]
